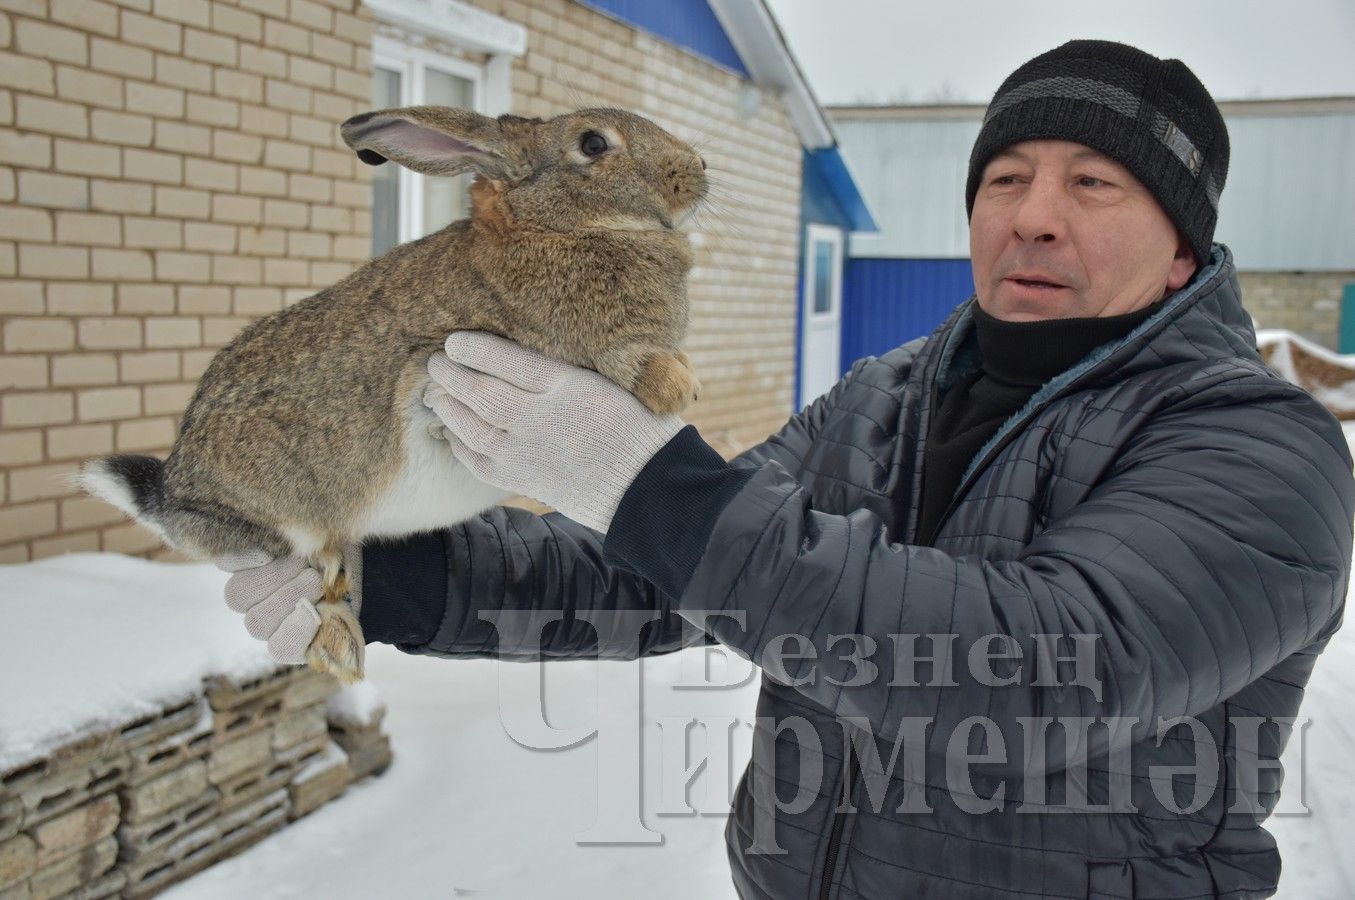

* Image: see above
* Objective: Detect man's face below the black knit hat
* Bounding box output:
[969,141,1195,321]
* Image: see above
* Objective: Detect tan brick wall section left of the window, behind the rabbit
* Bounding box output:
[0,0,371,561]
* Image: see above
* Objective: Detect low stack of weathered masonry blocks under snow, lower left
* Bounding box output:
[0,668,392,900]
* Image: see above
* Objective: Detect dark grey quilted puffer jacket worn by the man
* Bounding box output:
[362,245,1355,900]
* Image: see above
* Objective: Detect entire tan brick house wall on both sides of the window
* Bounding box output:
[0,0,801,563]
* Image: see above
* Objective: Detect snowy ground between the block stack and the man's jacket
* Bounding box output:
[163,645,756,900]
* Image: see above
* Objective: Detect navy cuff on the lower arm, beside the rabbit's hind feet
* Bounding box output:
[358,531,447,648]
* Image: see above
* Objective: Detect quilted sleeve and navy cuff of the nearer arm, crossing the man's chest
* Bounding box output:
[606,369,1355,769]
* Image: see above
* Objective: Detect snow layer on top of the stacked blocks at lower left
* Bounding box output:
[0,553,276,771]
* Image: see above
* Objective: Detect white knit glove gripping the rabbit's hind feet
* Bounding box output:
[213,550,324,666]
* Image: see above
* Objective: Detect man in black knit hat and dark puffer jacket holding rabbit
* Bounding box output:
[233,41,1355,900]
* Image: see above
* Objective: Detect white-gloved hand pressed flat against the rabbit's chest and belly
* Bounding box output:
[424,331,686,531]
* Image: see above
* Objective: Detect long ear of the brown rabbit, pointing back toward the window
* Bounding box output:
[339,106,524,178]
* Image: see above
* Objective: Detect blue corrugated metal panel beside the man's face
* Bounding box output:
[841,259,974,373]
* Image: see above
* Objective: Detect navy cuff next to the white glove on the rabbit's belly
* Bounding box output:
[603,426,753,599]
